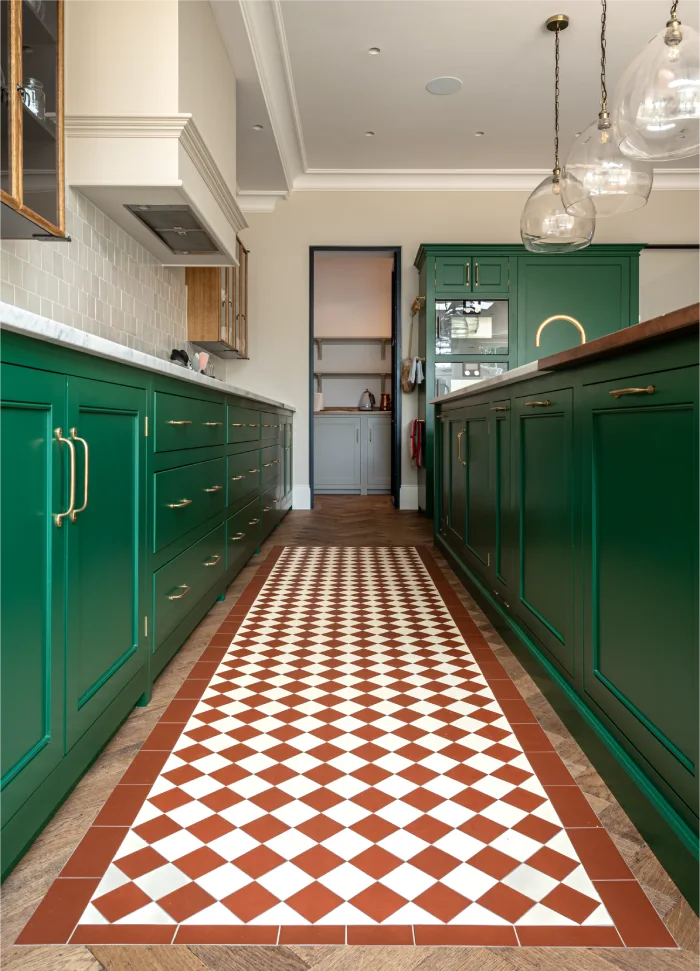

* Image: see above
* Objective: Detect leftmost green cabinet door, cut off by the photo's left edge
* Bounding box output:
[0,364,65,827]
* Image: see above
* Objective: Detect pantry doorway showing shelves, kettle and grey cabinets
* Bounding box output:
[309,246,401,508]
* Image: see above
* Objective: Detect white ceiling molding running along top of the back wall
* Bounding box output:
[294,169,700,192]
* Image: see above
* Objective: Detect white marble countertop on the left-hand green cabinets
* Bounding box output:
[0,301,296,411]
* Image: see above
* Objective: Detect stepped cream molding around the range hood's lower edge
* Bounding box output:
[65,113,248,232]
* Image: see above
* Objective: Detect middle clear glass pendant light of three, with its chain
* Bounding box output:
[562,0,654,217]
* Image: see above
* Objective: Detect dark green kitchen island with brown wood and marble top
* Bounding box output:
[432,304,700,880]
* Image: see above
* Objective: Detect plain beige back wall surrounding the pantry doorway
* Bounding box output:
[228,192,700,507]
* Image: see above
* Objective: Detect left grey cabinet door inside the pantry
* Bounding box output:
[314,415,362,492]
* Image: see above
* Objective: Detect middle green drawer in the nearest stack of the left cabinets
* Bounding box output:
[153,458,226,553]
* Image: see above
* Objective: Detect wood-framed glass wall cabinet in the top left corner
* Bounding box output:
[0,0,65,239]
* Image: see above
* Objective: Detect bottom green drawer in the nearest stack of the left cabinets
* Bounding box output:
[153,523,226,648]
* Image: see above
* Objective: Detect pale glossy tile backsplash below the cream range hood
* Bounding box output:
[0,188,220,374]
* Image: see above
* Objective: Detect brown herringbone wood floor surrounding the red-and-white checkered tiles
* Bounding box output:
[0,496,700,971]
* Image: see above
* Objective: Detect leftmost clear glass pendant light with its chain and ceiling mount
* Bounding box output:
[520,14,595,253]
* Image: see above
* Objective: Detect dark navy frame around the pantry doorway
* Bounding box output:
[309,246,401,509]
